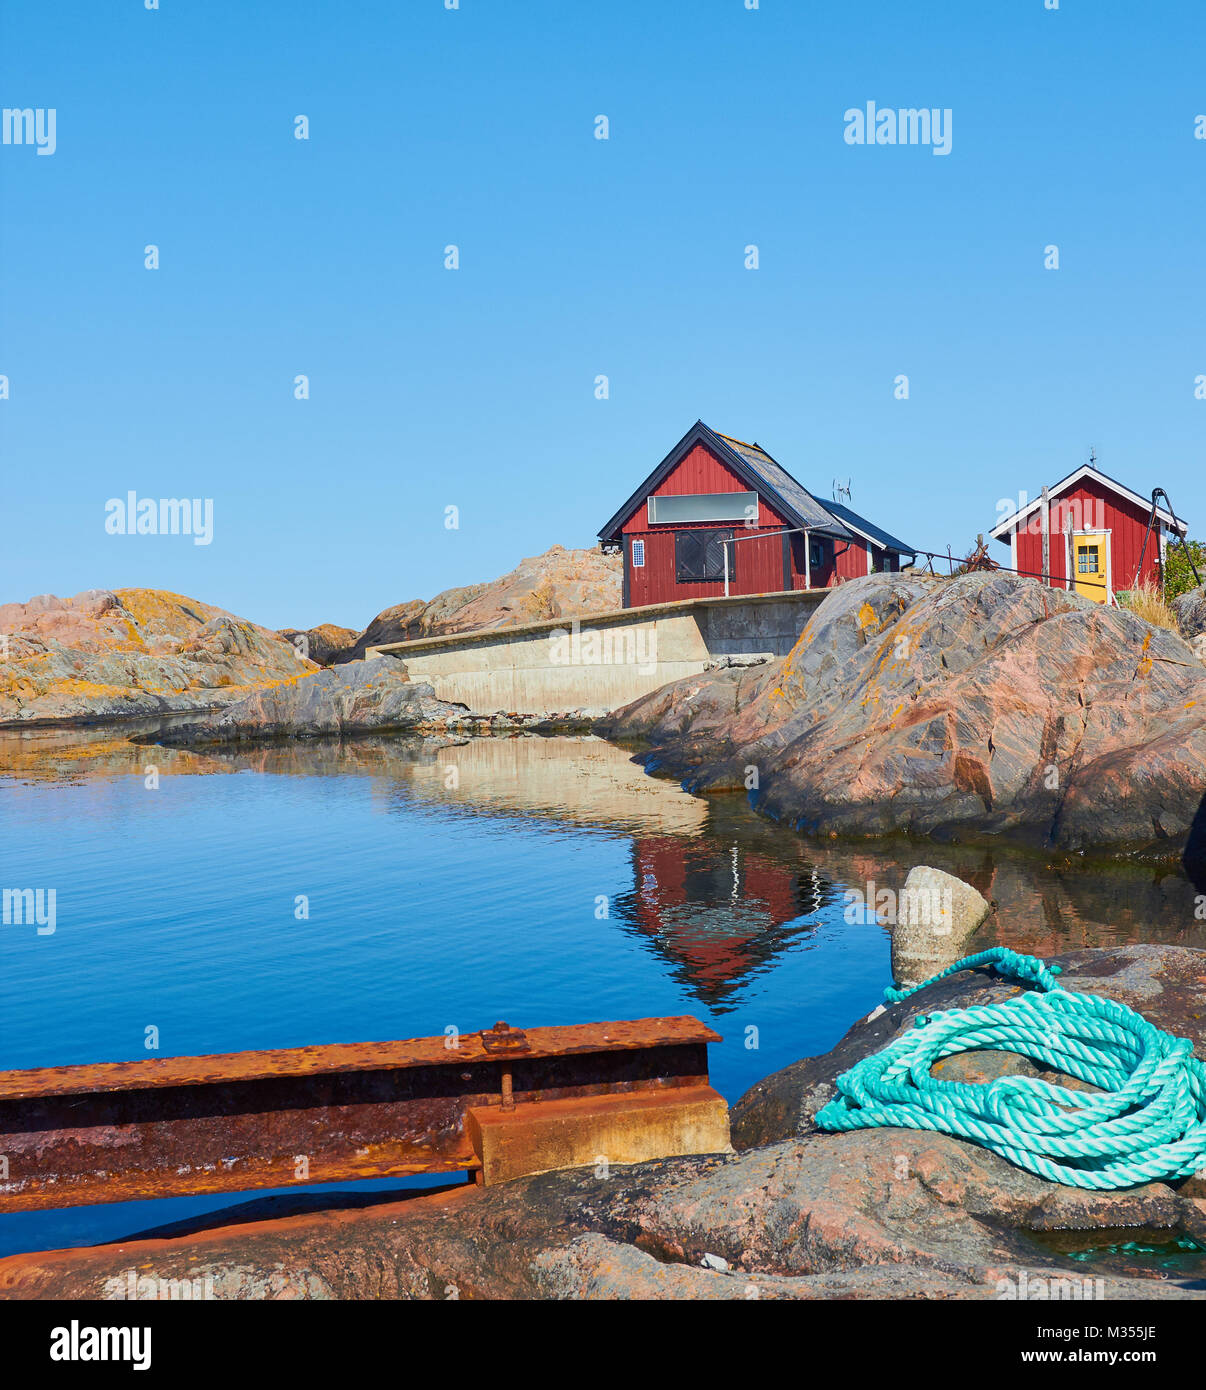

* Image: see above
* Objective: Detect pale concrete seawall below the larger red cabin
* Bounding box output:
[365,589,828,719]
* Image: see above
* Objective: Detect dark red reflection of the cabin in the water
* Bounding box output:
[613,835,838,1013]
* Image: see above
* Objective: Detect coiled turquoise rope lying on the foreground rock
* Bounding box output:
[817,947,1206,1190]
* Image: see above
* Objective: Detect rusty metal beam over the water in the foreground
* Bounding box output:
[0,1016,727,1212]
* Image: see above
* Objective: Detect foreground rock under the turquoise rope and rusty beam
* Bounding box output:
[7,945,1206,1300]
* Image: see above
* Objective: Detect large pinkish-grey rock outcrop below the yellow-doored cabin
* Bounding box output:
[597,573,1206,856]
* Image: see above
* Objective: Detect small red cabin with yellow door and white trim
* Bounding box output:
[992,460,1185,603]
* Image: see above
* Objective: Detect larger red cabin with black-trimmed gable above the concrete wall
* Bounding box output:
[599,420,914,607]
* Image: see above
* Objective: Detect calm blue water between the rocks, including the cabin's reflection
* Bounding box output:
[0,734,1178,1254]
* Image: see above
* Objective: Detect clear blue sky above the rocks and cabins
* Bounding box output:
[0,0,1206,627]
